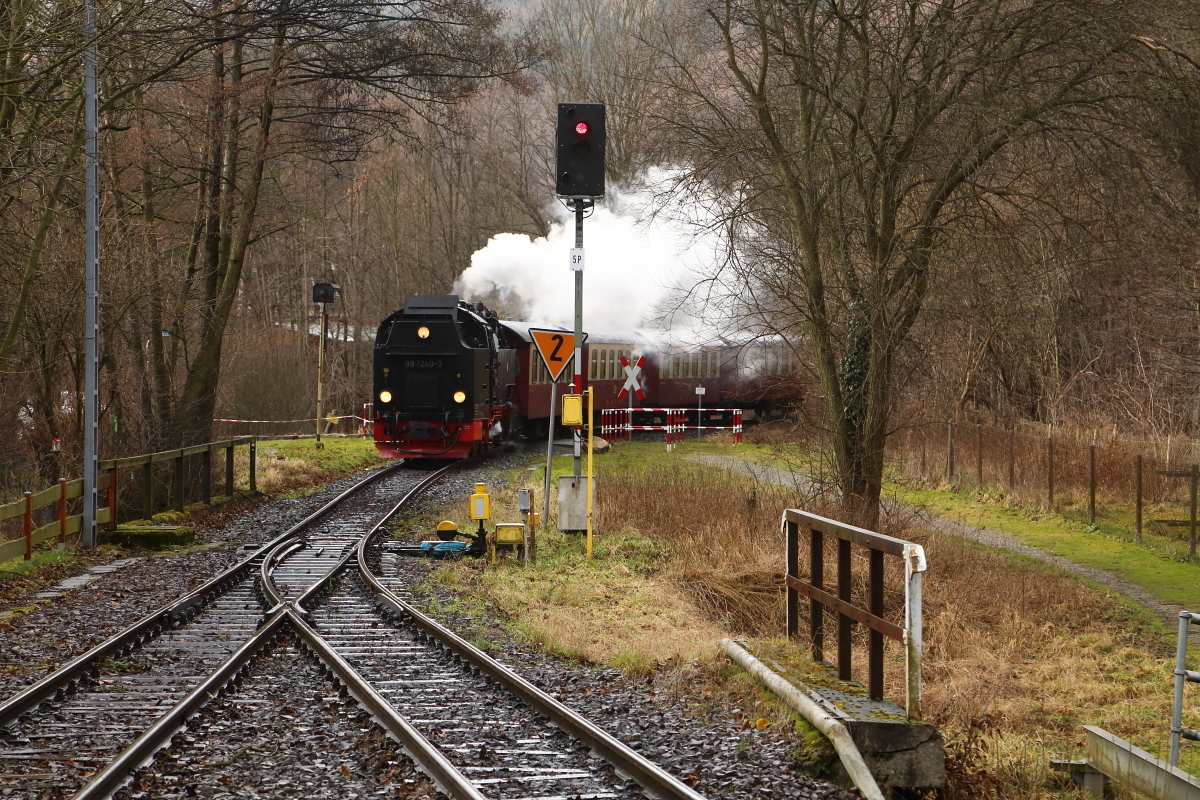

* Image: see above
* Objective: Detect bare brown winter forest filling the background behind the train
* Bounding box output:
[0,0,1200,520]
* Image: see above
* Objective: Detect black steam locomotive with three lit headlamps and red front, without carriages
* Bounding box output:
[374,295,508,458]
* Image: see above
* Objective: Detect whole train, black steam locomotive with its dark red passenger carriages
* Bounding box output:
[373,295,804,458]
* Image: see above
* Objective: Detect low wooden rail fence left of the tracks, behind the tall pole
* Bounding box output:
[0,437,258,563]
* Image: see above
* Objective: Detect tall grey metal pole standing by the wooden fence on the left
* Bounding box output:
[80,0,100,548]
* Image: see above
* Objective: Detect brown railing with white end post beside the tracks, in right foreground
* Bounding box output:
[782,509,926,720]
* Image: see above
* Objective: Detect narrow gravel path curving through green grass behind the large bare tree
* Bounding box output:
[688,456,1200,644]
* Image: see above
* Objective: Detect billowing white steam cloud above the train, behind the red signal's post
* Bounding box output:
[455,176,720,338]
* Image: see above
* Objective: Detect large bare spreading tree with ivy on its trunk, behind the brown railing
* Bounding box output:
[662,0,1129,524]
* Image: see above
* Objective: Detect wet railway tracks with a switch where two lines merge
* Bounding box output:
[0,455,700,800]
